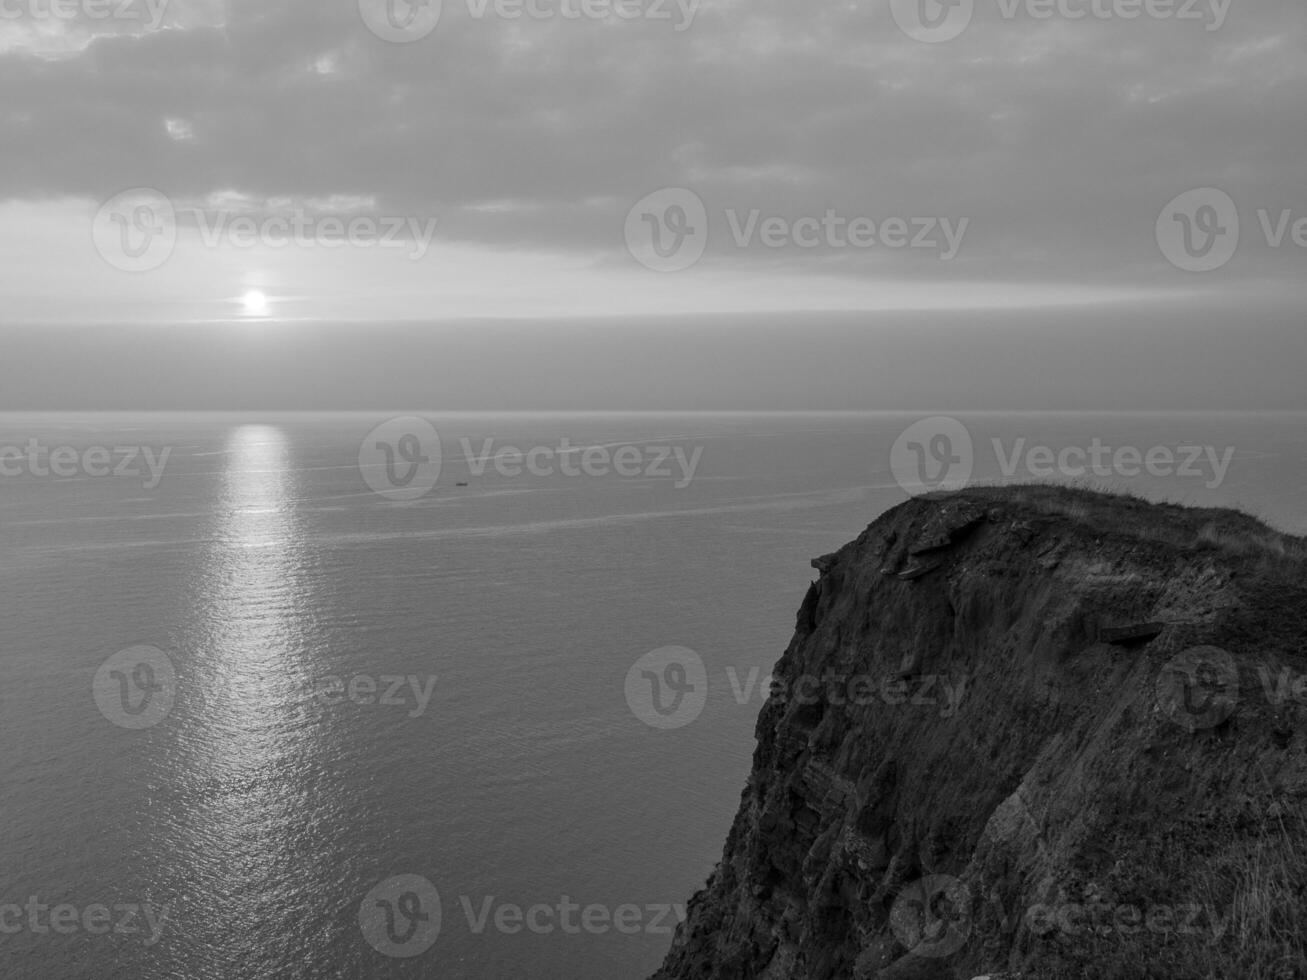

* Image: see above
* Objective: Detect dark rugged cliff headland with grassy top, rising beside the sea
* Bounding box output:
[656,487,1307,980]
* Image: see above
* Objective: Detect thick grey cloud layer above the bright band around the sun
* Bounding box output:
[0,0,1307,318]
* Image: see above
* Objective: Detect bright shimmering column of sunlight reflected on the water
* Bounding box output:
[172,425,331,953]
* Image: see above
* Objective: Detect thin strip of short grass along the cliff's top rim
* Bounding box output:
[927,483,1307,572]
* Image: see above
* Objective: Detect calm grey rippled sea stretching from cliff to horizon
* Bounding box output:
[0,414,1307,980]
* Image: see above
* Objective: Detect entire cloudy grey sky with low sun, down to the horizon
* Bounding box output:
[0,0,1307,409]
